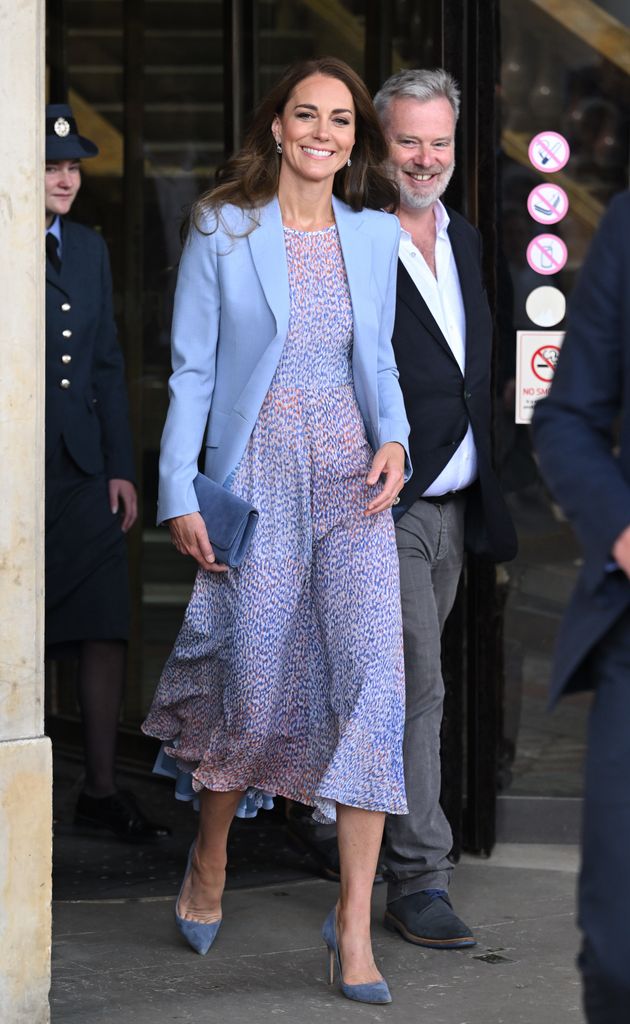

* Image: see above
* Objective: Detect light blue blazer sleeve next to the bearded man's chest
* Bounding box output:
[378,214,412,480]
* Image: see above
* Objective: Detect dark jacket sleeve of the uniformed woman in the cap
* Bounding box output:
[93,236,135,480]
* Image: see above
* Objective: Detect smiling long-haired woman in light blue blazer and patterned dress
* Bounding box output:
[143,58,409,1002]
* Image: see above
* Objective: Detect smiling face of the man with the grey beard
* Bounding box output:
[383,96,455,210]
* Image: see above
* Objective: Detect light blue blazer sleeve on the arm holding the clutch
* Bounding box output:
[158,212,221,523]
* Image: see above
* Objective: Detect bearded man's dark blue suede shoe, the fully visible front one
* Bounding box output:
[384,889,476,949]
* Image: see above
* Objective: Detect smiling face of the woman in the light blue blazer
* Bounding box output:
[271,75,355,190]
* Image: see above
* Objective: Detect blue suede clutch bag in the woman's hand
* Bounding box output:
[194,473,258,568]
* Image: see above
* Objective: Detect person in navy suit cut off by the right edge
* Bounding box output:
[534,193,630,1024]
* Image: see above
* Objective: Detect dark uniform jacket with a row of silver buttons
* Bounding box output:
[46,220,134,480]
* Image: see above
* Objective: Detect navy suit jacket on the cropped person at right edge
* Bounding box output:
[534,193,630,702]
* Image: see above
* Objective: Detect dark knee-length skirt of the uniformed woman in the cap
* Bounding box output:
[46,441,129,649]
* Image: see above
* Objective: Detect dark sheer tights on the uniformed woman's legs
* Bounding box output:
[77,640,127,797]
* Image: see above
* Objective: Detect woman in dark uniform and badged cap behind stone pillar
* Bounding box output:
[45,104,168,840]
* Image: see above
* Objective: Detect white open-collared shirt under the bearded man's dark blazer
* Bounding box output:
[398,200,477,498]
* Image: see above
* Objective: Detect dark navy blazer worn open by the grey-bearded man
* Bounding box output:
[392,209,516,561]
